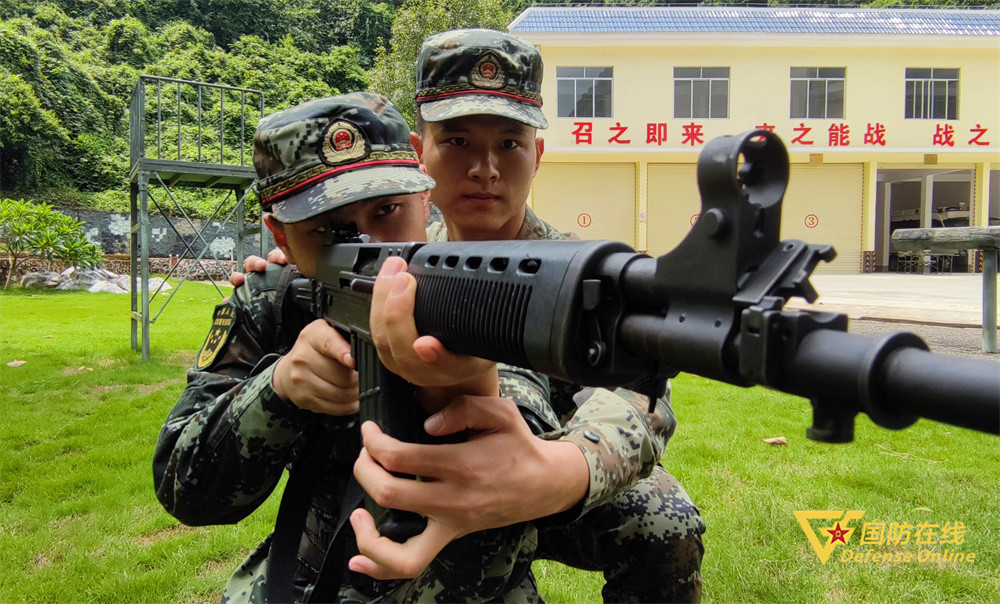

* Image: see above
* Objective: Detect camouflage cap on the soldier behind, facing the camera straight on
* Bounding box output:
[416,29,549,128]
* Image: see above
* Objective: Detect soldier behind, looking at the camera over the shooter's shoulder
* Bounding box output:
[363,30,704,602]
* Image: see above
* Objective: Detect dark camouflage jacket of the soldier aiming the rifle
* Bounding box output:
[153,265,556,602]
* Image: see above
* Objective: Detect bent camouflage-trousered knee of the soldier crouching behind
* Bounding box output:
[535,466,705,602]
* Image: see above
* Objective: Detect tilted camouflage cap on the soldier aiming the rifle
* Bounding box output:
[253,92,434,223]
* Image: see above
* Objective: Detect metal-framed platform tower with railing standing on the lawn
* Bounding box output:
[129,75,268,360]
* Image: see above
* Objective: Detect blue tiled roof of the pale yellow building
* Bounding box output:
[509,6,1000,36]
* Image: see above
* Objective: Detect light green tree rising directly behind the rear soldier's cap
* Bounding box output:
[370,0,512,124]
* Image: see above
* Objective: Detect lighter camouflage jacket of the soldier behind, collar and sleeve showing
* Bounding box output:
[427,207,677,517]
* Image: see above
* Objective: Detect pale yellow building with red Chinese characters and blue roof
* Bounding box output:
[509,7,1000,272]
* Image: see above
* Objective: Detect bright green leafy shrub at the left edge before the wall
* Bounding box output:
[0,199,104,287]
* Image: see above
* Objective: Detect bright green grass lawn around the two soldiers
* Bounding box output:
[0,283,1000,603]
